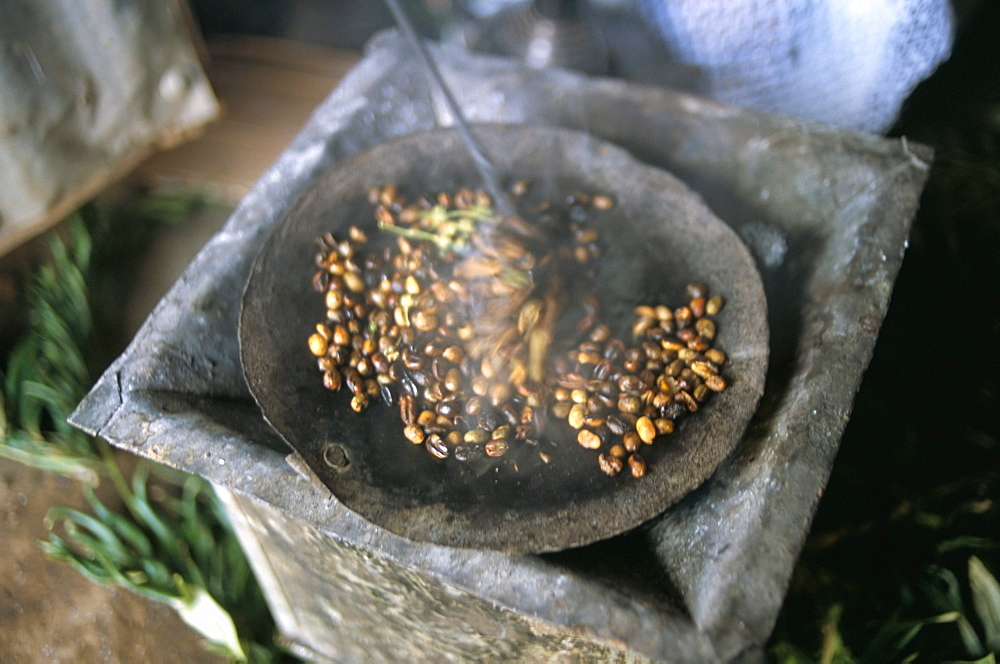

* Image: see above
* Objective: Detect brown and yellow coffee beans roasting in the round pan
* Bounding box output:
[308,182,727,477]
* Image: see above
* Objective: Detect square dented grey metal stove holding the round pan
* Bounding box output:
[72,35,930,661]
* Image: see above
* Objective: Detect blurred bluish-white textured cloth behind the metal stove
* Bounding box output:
[641,0,953,132]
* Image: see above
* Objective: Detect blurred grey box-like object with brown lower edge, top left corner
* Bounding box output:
[0,0,219,255]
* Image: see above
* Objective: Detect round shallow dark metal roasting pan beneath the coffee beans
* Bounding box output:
[239,125,768,553]
